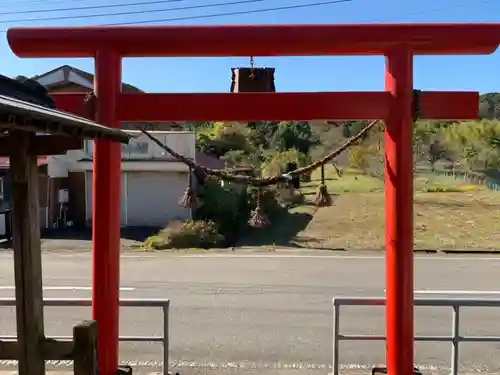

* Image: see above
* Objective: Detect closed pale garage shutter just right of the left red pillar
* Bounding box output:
[126,172,190,227]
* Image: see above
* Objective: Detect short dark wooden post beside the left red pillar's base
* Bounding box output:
[73,320,99,375]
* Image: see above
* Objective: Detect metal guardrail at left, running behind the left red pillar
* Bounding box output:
[0,298,170,375]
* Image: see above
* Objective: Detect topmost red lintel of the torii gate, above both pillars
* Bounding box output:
[7,23,500,57]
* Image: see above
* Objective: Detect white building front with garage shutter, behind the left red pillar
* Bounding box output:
[48,132,196,227]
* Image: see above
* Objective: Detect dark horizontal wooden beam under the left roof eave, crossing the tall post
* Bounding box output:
[0,135,83,156]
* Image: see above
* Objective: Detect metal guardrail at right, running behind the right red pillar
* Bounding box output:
[332,297,500,375]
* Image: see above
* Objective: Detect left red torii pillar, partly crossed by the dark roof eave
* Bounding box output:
[93,49,122,375]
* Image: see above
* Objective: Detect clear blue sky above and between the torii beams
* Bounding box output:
[0,0,500,92]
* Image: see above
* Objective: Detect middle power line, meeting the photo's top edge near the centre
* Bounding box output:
[0,0,269,24]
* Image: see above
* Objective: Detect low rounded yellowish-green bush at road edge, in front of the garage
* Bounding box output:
[144,220,224,249]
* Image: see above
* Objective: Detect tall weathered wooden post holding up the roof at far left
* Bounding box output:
[10,131,45,375]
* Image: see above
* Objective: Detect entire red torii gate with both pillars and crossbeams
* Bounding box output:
[7,24,500,375]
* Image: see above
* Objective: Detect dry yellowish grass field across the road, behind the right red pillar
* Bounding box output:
[241,165,500,250]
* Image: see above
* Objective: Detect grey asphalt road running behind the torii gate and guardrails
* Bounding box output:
[0,252,500,374]
